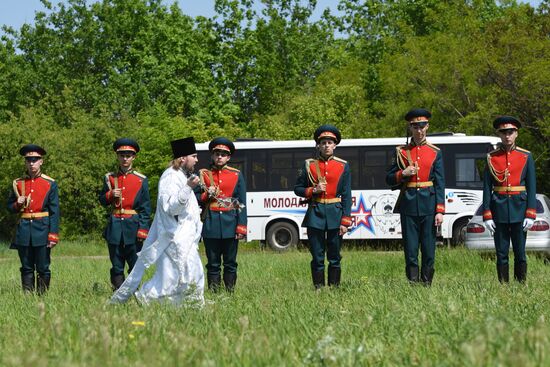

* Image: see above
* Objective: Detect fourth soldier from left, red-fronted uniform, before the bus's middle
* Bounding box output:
[294,125,351,289]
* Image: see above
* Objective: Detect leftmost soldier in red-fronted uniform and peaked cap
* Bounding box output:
[8,144,60,294]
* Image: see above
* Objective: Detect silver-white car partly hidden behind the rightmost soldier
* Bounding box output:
[465,194,550,256]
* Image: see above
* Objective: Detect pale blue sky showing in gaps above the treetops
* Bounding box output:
[0,0,541,29]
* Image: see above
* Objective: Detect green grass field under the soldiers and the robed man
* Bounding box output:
[0,242,550,367]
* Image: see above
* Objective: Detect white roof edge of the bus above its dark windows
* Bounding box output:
[197,134,500,151]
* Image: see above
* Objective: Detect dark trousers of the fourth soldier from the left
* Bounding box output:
[307,227,342,272]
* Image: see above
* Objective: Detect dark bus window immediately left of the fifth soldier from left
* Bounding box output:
[361,147,395,190]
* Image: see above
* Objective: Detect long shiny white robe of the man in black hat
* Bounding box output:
[110,168,204,305]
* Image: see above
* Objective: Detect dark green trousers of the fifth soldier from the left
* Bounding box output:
[401,214,435,269]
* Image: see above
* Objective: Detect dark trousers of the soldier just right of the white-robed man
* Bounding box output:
[203,238,239,276]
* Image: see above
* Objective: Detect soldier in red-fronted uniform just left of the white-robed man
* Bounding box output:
[99,138,151,290]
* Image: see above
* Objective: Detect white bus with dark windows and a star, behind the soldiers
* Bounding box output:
[197,133,500,250]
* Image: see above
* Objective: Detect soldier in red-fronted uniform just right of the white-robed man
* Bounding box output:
[198,137,247,292]
